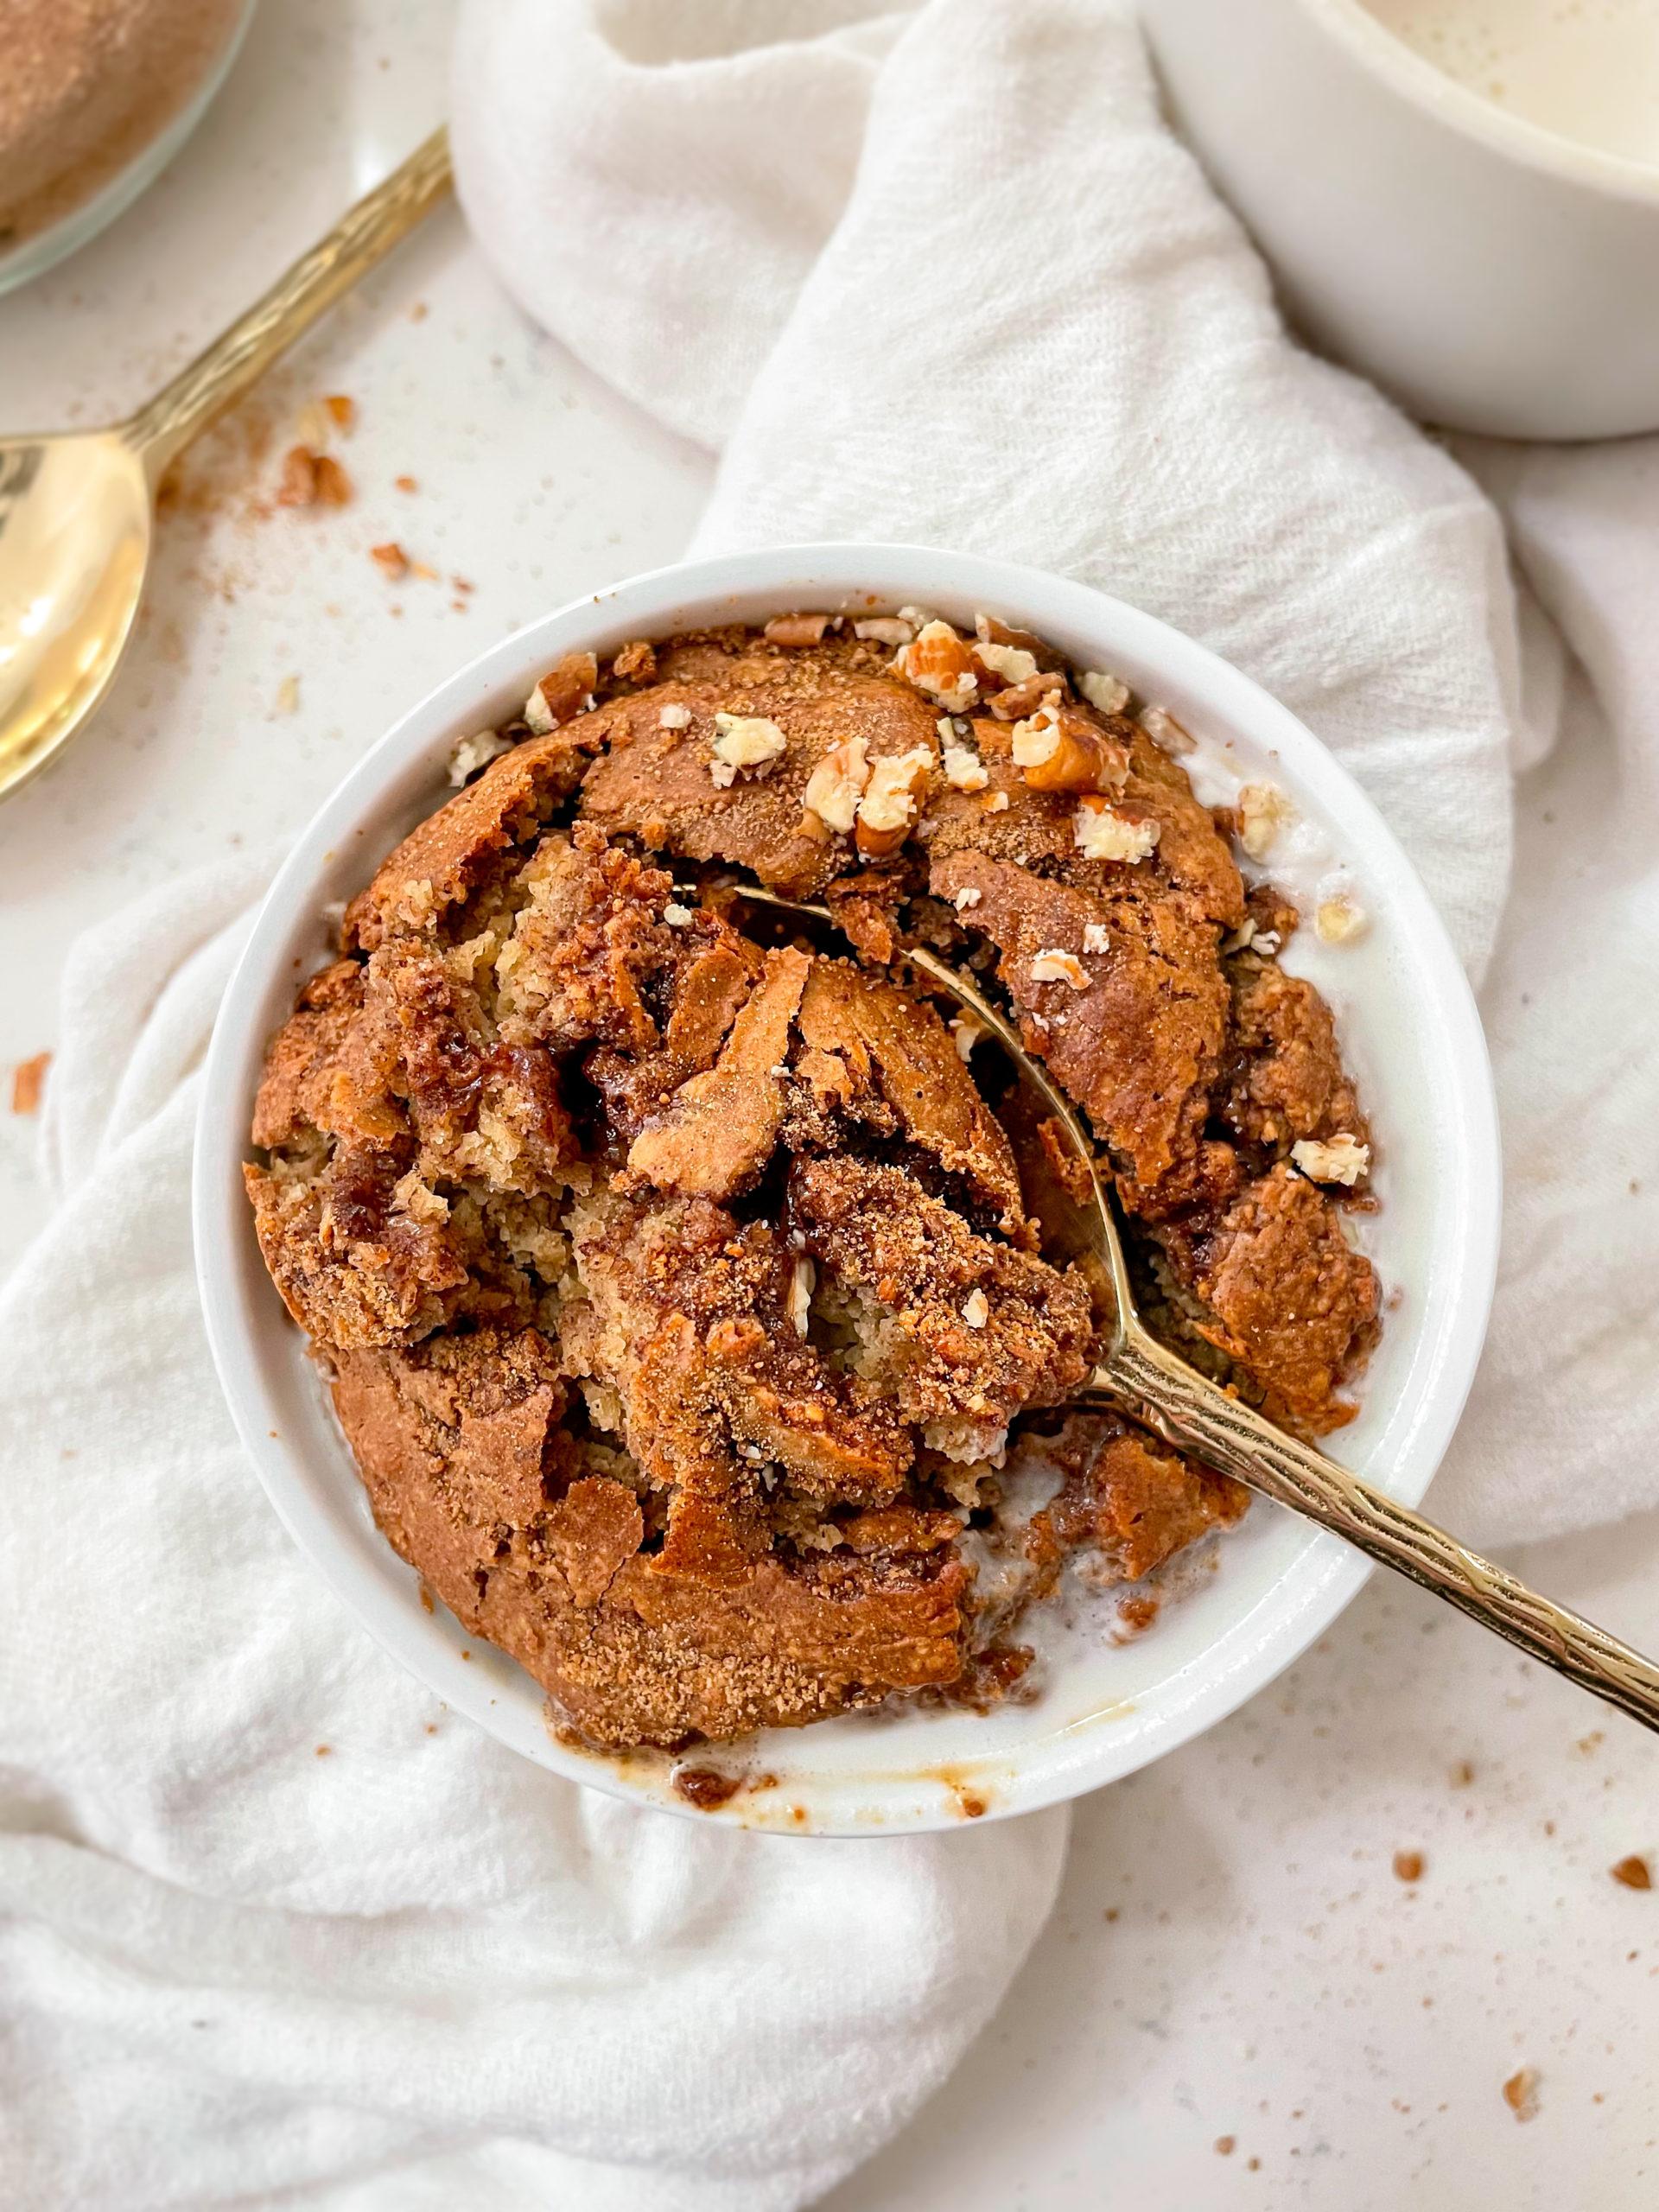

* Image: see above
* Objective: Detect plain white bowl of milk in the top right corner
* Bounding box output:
[1141,0,1659,438]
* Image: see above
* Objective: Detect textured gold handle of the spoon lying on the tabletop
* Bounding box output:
[124,128,451,485]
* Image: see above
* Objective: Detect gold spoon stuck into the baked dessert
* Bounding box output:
[721,882,1659,1730]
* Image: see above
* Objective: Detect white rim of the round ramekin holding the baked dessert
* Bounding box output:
[193,544,1500,1836]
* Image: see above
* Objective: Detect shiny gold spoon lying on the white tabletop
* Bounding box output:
[0,130,449,798]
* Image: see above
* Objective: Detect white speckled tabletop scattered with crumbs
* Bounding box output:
[0,0,1659,2212]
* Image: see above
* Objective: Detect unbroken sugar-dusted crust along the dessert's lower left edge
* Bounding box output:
[334,1332,967,1747]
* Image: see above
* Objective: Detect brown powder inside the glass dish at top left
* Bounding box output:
[0,0,241,245]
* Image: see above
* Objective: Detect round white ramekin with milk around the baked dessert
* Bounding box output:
[194,544,1500,1836]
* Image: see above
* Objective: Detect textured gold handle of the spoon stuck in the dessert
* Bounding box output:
[1090,1330,1659,1730]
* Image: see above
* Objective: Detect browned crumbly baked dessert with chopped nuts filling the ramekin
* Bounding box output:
[248,615,1378,1745]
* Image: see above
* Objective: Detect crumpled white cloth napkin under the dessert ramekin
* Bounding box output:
[0,0,1659,2212]
